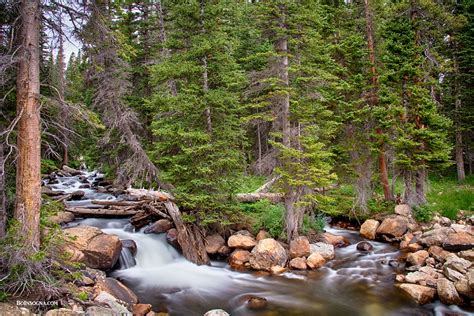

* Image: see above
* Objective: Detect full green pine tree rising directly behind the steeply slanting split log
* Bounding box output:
[151,1,244,215]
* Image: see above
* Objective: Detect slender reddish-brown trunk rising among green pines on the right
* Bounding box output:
[364,0,393,201]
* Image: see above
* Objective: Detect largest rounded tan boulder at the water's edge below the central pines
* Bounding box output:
[249,238,288,271]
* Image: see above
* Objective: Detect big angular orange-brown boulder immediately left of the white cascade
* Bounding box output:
[64,225,122,269]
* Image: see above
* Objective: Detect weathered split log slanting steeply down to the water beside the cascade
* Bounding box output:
[164,201,209,265]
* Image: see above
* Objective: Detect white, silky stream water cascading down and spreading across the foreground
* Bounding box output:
[49,173,469,316]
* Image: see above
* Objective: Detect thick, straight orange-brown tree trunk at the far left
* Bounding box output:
[14,0,41,253]
